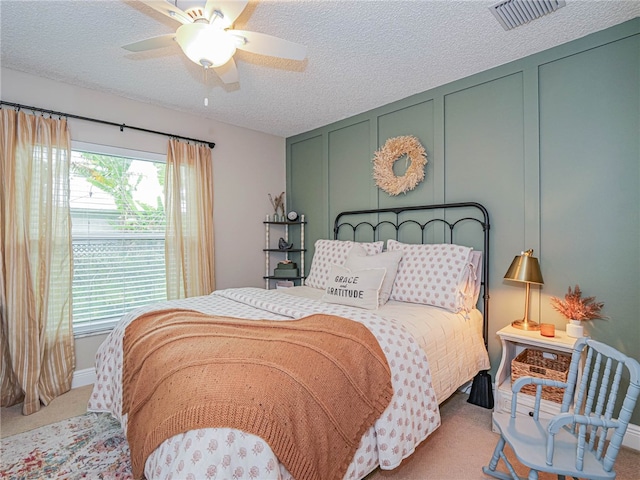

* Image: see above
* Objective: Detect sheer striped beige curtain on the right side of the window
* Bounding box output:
[165,139,215,300]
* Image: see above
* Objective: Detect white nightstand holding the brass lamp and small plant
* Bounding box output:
[493,325,578,426]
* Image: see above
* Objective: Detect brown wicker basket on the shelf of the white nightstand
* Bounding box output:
[511,348,571,403]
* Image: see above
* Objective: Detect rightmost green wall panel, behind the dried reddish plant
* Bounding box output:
[539,35,640,356]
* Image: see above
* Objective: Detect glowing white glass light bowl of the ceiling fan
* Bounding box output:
[176,23,236,67]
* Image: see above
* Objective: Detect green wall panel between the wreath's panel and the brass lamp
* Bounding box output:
[444,72,525,365]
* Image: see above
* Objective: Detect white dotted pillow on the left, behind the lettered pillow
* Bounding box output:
[305,239,384,289]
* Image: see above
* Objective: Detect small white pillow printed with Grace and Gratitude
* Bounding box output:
[322,265,386,310]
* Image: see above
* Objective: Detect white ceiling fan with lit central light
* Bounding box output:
[122,0,307,83]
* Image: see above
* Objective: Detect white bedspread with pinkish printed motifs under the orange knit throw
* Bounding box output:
[88,288,440,480]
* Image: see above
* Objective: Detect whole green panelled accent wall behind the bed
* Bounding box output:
[287,18,640,425]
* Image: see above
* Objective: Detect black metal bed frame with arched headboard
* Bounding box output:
[333,202,493,409]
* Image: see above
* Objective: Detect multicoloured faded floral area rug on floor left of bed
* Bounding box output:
[0,413,133,480]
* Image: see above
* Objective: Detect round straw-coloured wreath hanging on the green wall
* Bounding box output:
[373,136,427,195]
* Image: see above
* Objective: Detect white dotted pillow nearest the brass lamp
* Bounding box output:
[387,239,472,312]
